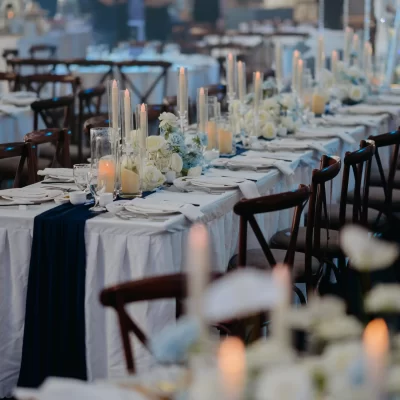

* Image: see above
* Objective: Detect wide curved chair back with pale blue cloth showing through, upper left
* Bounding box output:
[20,74,81,98]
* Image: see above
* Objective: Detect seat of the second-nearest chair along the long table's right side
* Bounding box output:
[270,227,343,258]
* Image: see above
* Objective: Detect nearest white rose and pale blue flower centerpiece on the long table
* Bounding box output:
[138,113,206,190]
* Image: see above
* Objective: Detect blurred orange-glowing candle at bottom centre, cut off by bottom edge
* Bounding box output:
[218,337,246,400]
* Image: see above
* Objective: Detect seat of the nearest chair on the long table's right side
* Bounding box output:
[229,249,319,282]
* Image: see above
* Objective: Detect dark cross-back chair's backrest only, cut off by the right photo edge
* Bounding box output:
[368,128,400,218]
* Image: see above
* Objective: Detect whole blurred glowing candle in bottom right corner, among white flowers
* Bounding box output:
[363,319,389,399]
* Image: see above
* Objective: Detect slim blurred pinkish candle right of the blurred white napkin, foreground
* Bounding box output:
[271,264,292,347]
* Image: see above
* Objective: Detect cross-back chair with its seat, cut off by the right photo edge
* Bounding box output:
[347,129,400,219]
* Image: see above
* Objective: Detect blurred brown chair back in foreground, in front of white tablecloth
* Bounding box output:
[100,274,225,374]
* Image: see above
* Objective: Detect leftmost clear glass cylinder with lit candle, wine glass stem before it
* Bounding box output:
[88,128,117,212]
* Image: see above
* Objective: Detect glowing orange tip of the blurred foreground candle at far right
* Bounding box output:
[363,319,389,359]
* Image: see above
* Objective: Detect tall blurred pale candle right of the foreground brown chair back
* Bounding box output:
[186,224,210,339]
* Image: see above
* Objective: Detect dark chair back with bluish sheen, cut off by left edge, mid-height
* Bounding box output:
[0,142,37,188]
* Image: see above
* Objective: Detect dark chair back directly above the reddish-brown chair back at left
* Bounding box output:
[31,95,75,131]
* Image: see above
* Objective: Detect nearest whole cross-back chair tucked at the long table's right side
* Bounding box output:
[229,185,312,303]
